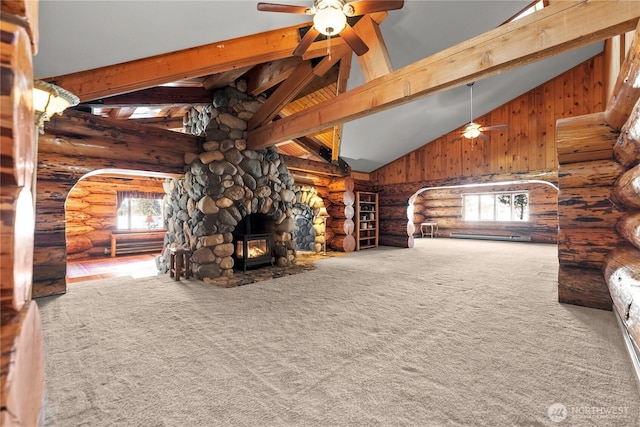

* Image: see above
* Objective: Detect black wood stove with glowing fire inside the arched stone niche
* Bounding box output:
[233,214,273,271]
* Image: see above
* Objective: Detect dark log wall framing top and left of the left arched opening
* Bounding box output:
[33,110,198,297]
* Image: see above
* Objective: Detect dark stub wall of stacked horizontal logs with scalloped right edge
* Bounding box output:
[556,113,624,310]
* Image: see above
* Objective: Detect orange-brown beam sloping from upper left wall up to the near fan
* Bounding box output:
[44,23,345,102]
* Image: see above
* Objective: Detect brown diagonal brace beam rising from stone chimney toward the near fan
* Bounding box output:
[249,46,351,129]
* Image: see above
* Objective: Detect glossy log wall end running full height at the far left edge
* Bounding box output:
[0,0,44,426]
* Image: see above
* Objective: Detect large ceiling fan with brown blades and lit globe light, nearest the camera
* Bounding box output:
[258,0,404,56]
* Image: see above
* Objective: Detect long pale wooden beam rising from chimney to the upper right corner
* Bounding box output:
[248,0,640,149]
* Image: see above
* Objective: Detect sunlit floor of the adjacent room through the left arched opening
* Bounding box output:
[67,254,158,283]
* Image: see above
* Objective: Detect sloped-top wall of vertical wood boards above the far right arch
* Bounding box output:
[371,54,605,186]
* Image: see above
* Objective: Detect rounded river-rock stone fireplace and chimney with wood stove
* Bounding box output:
[157,81,320,280]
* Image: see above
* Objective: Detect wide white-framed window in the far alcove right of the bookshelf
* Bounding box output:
[462,192,529,221]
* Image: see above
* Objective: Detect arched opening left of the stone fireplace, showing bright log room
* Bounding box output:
[64,169,173,282]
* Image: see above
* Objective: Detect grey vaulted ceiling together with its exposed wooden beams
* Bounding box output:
[34,0,635,172]
